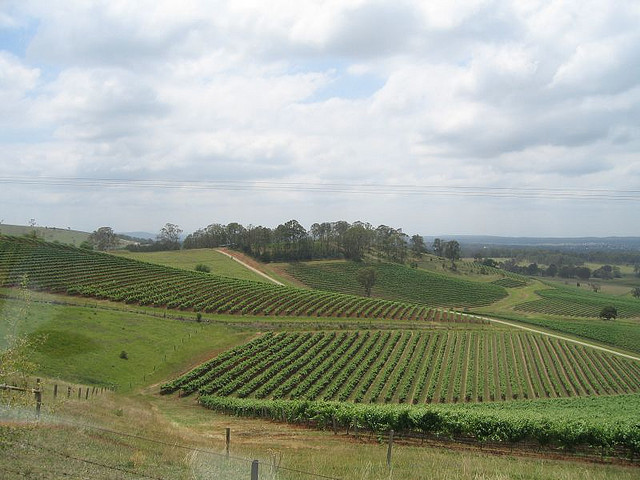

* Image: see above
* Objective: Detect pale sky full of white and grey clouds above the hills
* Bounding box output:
[0,0,640,236]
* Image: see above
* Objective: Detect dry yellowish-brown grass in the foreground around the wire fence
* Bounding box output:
[0,394,638,480]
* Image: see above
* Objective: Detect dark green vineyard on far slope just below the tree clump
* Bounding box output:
[287,262,507,308]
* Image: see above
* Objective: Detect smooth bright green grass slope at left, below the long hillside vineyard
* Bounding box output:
[0,300,254,391]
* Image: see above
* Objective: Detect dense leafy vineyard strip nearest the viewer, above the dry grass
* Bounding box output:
[200,395,640,459]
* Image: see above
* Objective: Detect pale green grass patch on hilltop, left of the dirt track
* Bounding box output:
[112,248,270,283]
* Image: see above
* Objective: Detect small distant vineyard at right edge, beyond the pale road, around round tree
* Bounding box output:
[516,288,640,318]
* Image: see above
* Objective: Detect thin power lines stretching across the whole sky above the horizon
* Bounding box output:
[0,176,640,201]
